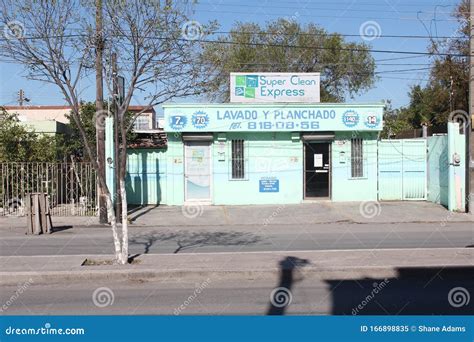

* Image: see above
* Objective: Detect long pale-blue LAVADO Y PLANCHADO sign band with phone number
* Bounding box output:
[164,104,383,132]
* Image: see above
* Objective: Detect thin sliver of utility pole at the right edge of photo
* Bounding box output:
[466,0,474,215]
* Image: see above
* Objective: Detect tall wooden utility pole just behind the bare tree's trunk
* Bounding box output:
[95,0,108,223]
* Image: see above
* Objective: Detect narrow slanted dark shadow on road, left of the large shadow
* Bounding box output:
[267,256,309,315]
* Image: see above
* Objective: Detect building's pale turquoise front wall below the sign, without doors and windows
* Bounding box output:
[127,132,377,205]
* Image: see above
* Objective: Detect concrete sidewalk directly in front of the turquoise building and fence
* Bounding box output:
[0,201,474,229]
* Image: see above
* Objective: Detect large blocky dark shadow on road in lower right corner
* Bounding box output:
[326,267,474,315]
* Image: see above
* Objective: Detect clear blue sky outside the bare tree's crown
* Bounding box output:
[0,0,458,109]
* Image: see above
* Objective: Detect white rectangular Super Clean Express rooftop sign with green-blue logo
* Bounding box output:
[230,73,320,103]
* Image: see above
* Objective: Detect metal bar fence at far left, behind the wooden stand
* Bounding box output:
[0,162,97,216]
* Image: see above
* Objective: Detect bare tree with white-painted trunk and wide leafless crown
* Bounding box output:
[0,0,213,264]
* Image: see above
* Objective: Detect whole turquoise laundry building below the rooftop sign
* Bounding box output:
[123,103,383,205]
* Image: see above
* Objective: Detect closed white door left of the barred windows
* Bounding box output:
[184,141,211,202]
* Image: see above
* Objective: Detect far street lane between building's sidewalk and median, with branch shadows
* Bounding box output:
[0,222,474,256]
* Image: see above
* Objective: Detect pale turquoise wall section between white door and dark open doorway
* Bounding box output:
[212,132,303,205]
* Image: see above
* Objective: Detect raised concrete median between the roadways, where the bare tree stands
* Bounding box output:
[0,248,474,285]
